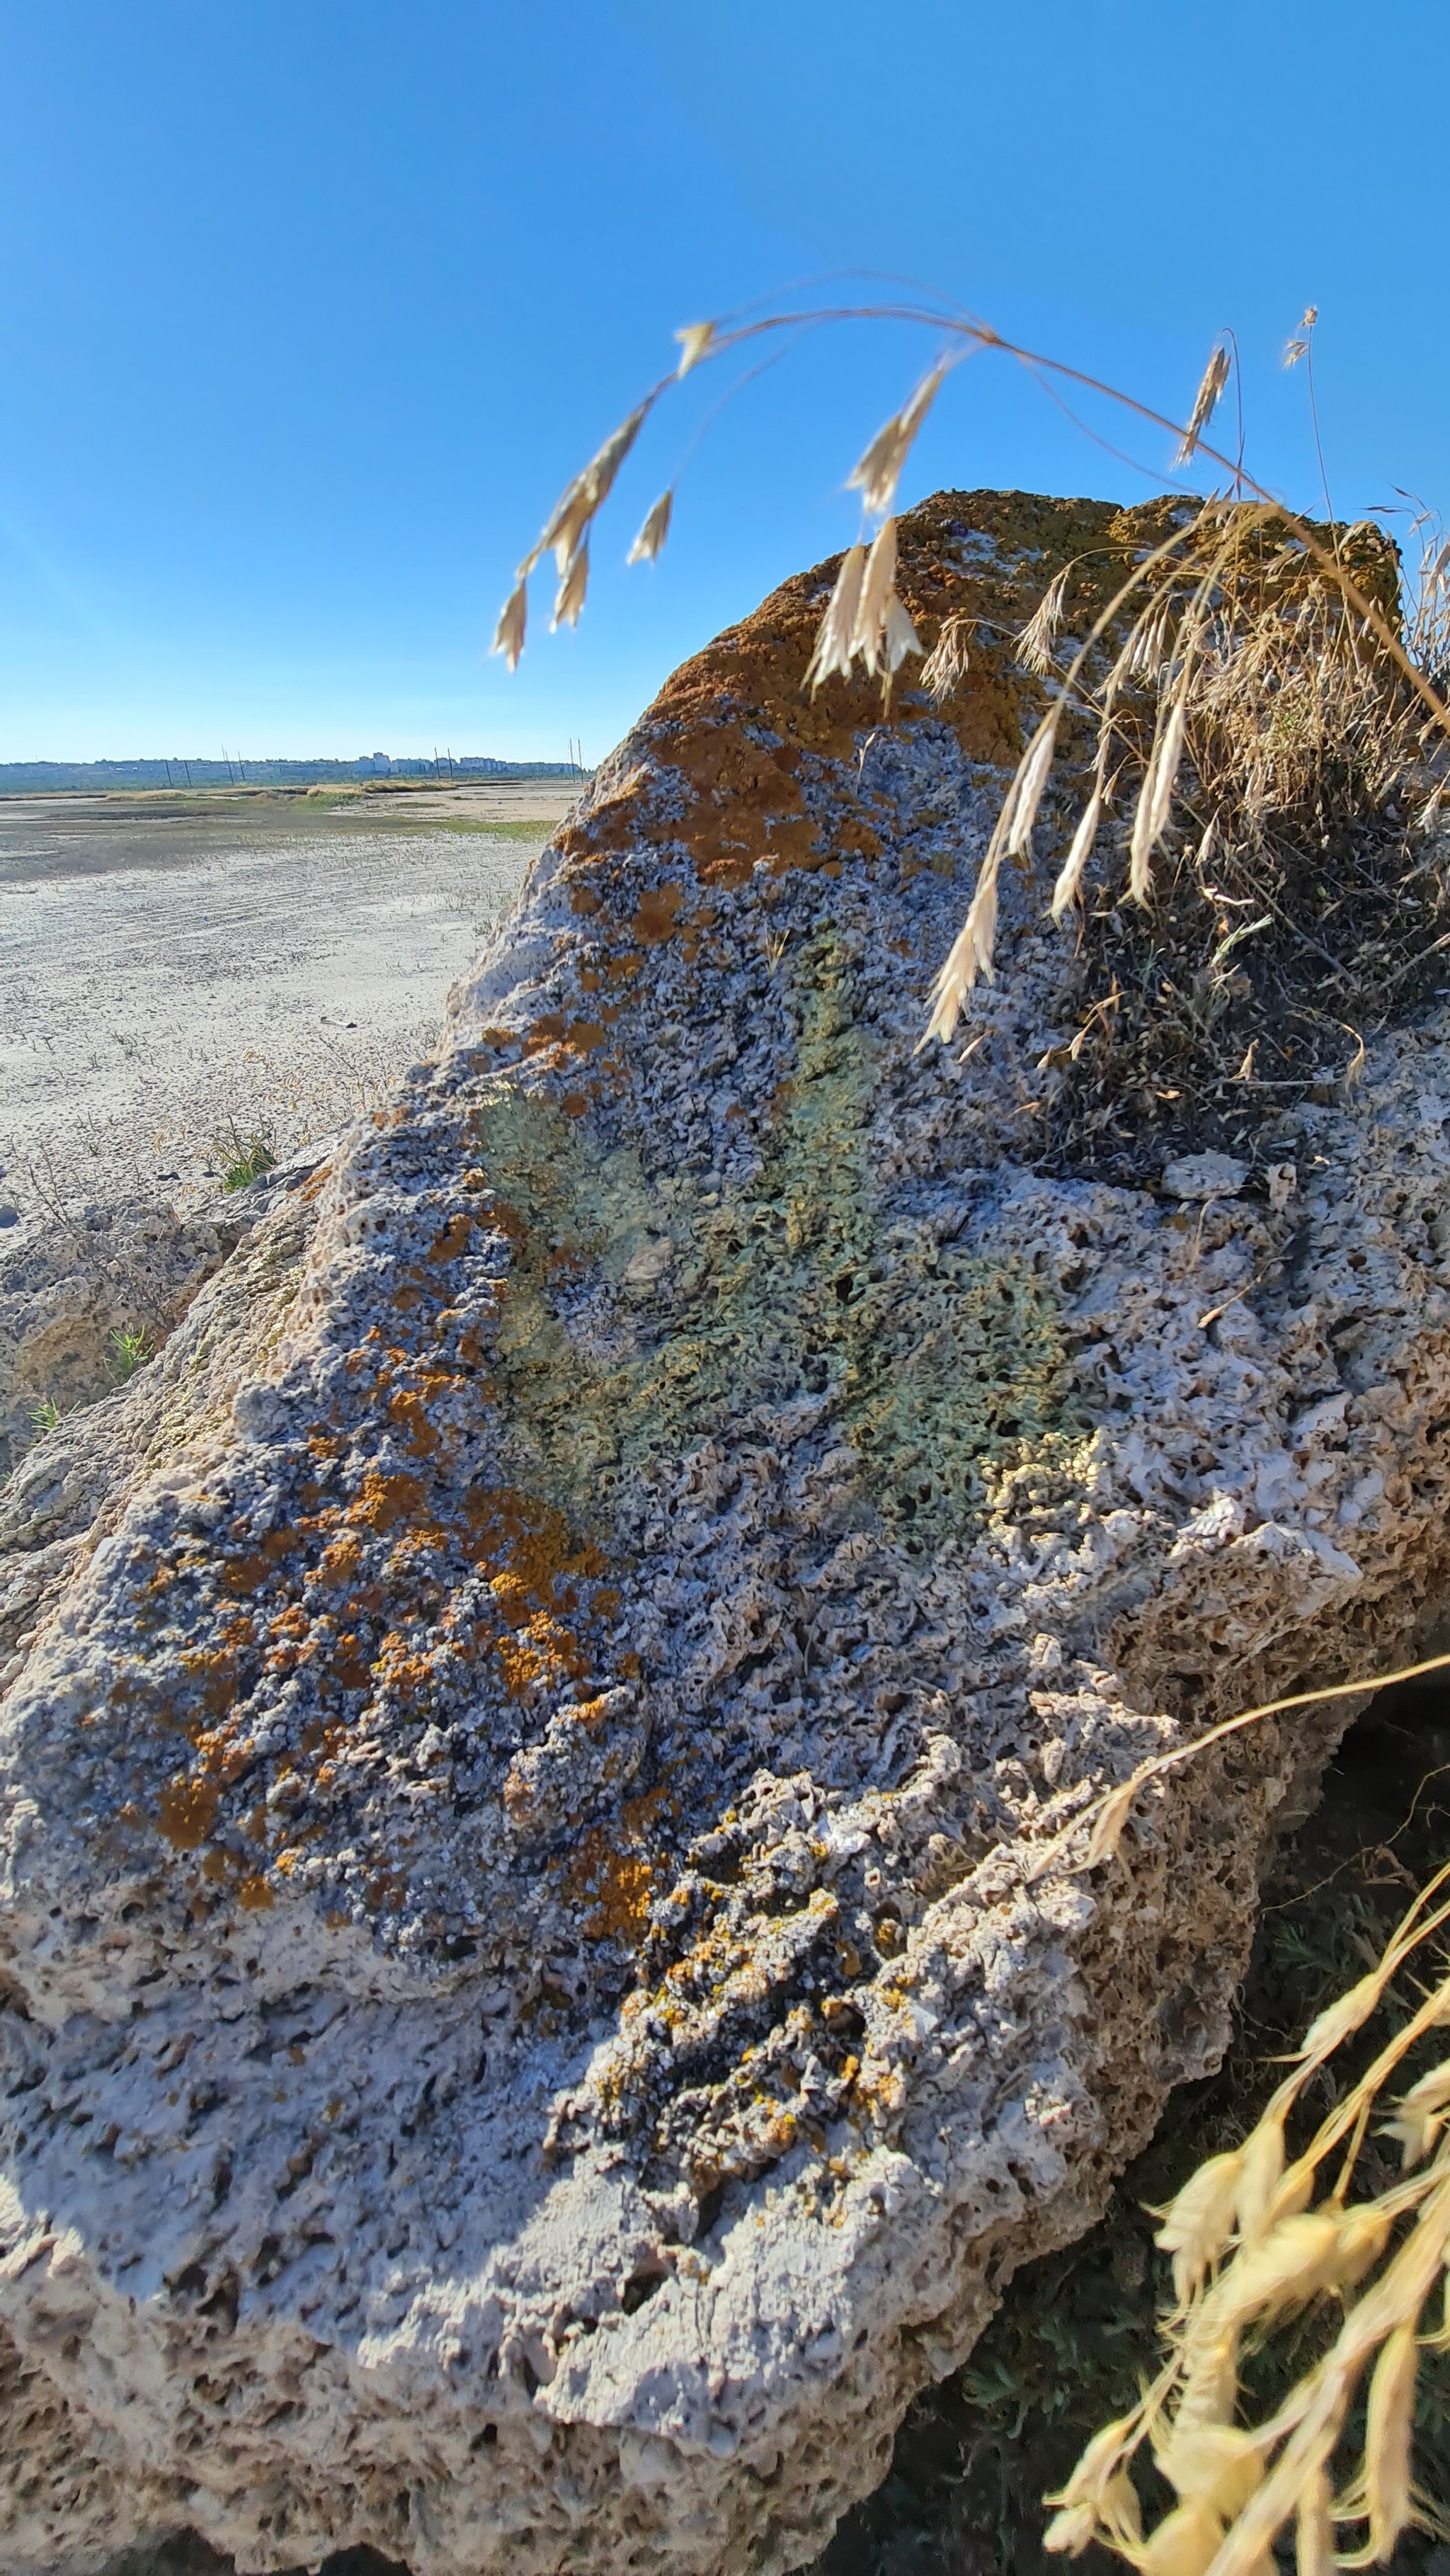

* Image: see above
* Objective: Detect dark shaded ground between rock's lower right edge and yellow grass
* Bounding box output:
[814,1675,1450,2576]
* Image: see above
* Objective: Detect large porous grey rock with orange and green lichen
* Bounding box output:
[0,492,1450,2576]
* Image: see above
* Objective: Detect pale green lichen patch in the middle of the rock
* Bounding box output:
[474,937,1069,1548]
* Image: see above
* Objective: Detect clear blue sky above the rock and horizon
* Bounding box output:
[0,0,1450,760]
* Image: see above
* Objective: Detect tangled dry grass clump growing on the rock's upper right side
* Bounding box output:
[958,500,1450,1180]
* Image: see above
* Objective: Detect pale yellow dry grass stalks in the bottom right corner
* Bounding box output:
[1046,1656,1450,2576]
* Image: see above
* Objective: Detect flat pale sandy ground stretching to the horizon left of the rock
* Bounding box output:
[0,780,577,1219]
